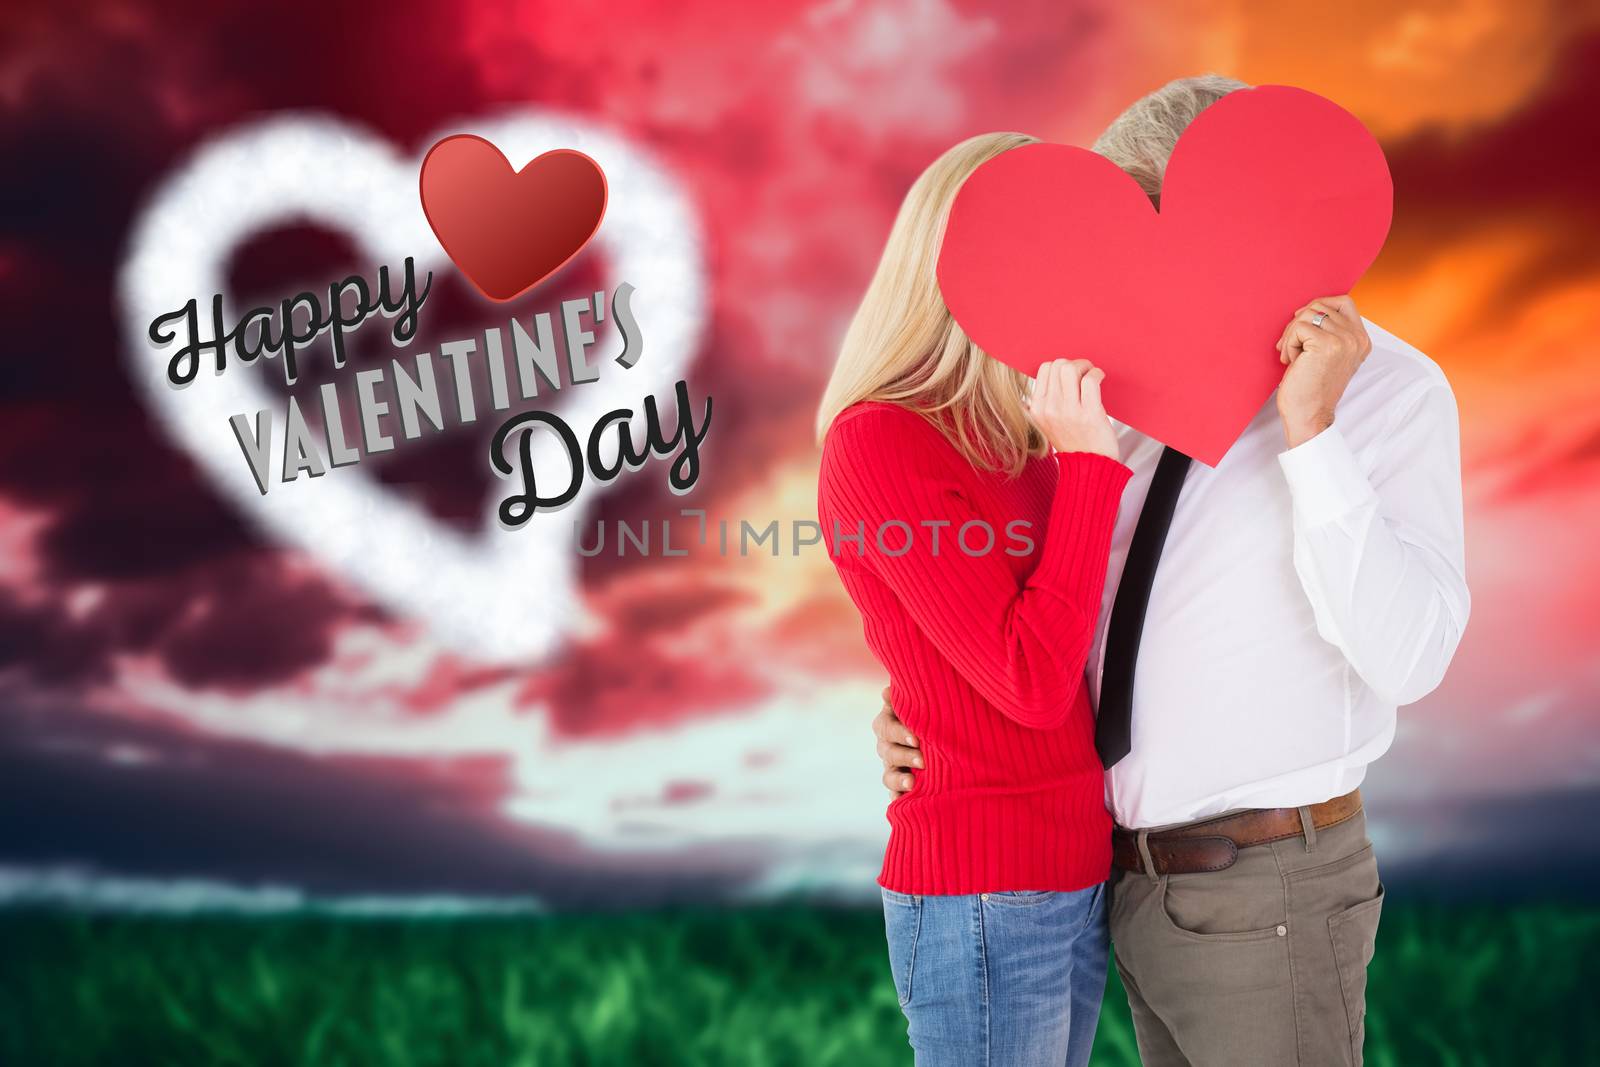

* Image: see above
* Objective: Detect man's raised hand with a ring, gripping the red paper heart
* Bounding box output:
[1278,296,1373,448]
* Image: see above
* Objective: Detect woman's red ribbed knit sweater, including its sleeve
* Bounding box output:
[818,403,1130,894]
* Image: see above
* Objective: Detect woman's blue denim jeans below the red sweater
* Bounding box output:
[883,885,1109,1067]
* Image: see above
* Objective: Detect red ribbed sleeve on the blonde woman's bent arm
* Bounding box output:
[819,419,1130,729]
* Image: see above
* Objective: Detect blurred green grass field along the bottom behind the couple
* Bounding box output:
[0,905,1600,1067]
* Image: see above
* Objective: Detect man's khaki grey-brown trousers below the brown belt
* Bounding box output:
[1110,814,1384,1067]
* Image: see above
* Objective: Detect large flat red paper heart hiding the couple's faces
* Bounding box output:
[938,85,1394,466]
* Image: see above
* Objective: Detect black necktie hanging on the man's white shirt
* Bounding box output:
[1094,448,1192,769]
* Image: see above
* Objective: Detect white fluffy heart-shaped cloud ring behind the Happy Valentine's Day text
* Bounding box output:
[118,110,706,659]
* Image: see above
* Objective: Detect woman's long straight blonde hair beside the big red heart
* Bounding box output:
[816,133,1046,474]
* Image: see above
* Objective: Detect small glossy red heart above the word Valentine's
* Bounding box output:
[422,133,606,301]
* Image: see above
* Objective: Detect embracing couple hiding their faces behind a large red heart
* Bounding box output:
[818,77,1469,1067]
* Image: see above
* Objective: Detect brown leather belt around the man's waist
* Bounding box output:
[1110,789,1362,875]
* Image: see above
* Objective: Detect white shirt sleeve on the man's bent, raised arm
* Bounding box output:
[1278,382,1470,704]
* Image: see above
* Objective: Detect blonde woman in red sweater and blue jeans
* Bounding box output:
[818,133,1128,1067]
